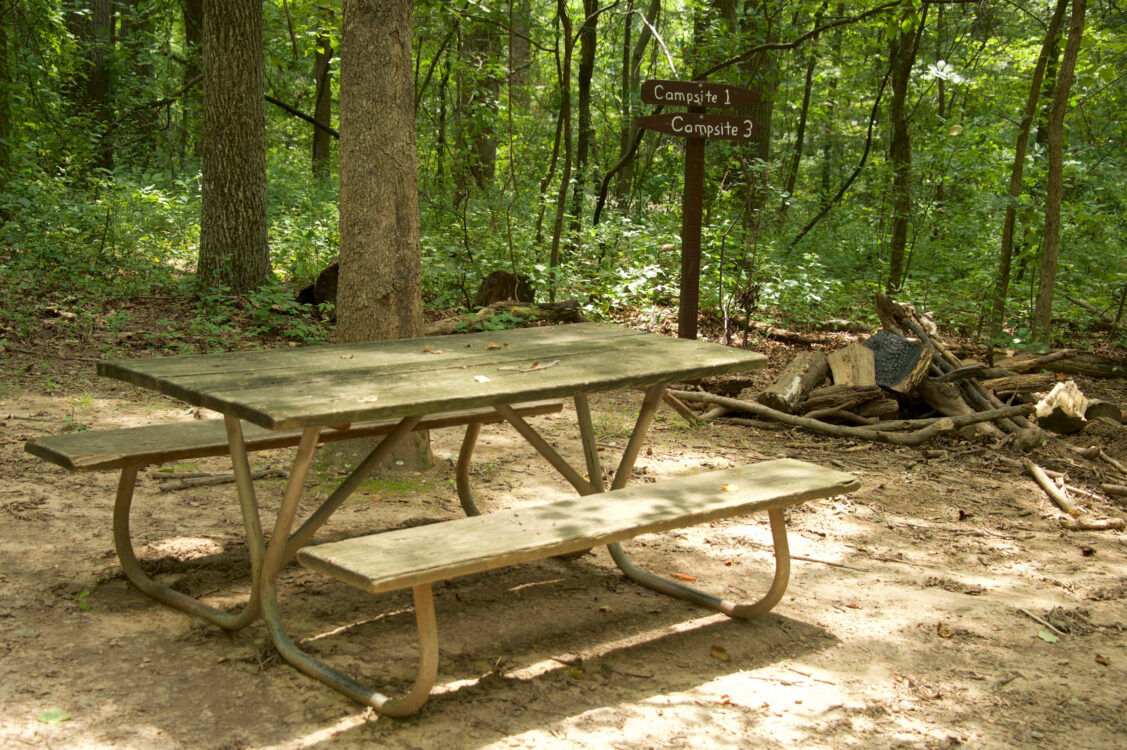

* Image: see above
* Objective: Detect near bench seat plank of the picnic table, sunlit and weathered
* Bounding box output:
[298,459,860,593]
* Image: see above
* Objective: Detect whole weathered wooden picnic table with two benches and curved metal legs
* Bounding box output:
[27,324,858,715]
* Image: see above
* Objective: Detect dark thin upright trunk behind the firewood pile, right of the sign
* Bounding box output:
[886,8,926,295]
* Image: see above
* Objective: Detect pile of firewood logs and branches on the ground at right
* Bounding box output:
[669,295,1127,528]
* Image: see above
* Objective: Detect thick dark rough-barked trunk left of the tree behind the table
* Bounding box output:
[196,0,270,293]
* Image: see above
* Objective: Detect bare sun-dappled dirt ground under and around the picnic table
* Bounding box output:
[0,306,1127,750]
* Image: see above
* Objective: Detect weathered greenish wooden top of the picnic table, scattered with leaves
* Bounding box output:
[98,323,766,430]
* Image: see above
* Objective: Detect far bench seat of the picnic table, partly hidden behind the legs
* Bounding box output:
[24,400,564,471]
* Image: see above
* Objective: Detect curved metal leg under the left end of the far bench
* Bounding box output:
[114,466,261,630]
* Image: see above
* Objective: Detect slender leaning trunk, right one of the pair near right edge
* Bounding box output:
[1033,0,1086,344]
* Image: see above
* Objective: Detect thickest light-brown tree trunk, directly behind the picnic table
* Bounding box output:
[336,0,429,469]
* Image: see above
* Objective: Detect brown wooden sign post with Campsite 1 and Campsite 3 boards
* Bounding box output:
[635,80,760,338]
